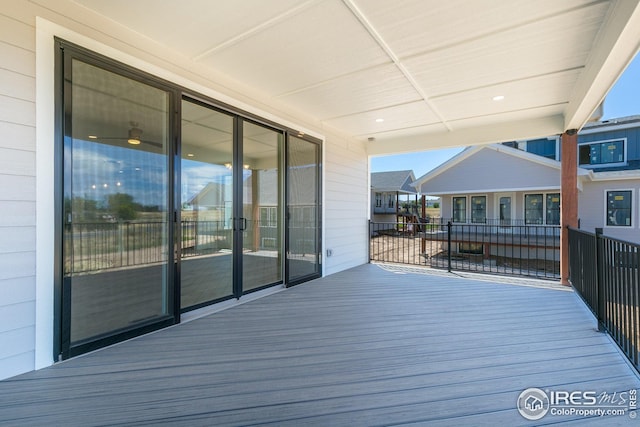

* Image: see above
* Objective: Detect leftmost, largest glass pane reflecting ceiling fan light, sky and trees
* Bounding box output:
[64,60,171,345]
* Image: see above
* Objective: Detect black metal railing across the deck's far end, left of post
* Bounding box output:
[369,219,560,279]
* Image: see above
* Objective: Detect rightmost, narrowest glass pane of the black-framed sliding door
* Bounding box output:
[287,136,320,284]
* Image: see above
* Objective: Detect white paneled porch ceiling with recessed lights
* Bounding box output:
[70,0,640,155]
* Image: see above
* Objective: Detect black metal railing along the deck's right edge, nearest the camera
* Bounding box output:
[569,228,640,370]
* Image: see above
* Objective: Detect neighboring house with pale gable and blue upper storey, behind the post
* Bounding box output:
[414,116,640,242]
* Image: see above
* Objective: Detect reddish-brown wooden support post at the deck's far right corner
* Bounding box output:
[560,129,578,285]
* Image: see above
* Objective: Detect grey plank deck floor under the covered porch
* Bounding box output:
[0,265,640,426]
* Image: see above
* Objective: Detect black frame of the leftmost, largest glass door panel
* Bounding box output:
[53,38,180,360]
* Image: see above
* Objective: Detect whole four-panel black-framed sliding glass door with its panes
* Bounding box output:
[54,40,321,358]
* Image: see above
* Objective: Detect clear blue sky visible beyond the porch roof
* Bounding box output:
[371,55,640,178]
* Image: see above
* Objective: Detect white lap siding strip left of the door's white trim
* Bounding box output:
[0,8,36,378]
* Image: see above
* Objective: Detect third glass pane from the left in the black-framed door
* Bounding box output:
[238,121,283,292]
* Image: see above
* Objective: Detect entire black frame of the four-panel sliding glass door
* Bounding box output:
[52,38,322,360]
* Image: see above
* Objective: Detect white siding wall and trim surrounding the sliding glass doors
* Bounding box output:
[0,1,369,379]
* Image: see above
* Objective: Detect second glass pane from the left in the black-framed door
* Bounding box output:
[180,100,234,308]
